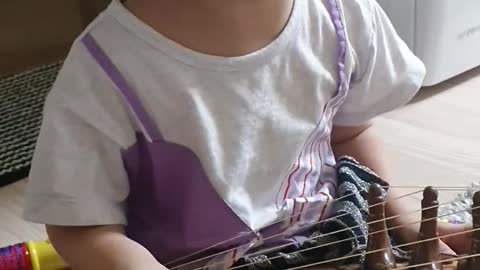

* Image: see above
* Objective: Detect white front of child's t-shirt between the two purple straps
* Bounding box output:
[80,1,352,232]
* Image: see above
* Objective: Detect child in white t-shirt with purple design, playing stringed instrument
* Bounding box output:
[25,0,468,270]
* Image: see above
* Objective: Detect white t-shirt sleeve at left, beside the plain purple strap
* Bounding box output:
[24,43,128,226]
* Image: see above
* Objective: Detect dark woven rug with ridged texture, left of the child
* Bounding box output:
[0,63,62,187]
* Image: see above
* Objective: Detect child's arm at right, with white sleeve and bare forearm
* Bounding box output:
[332,0,426,242]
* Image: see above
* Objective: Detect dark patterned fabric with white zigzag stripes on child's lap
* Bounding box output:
[234,157,409,270]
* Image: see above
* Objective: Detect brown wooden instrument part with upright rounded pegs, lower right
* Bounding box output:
[255,185,480,270]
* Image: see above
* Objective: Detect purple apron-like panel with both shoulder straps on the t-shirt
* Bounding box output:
[82,0,348,269]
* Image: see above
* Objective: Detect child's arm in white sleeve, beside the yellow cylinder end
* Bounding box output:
[24,42,165,270]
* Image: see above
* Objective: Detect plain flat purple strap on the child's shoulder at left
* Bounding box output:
[82,33,162,142]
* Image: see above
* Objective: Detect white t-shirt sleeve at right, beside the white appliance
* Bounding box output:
[333,0,426,126]
